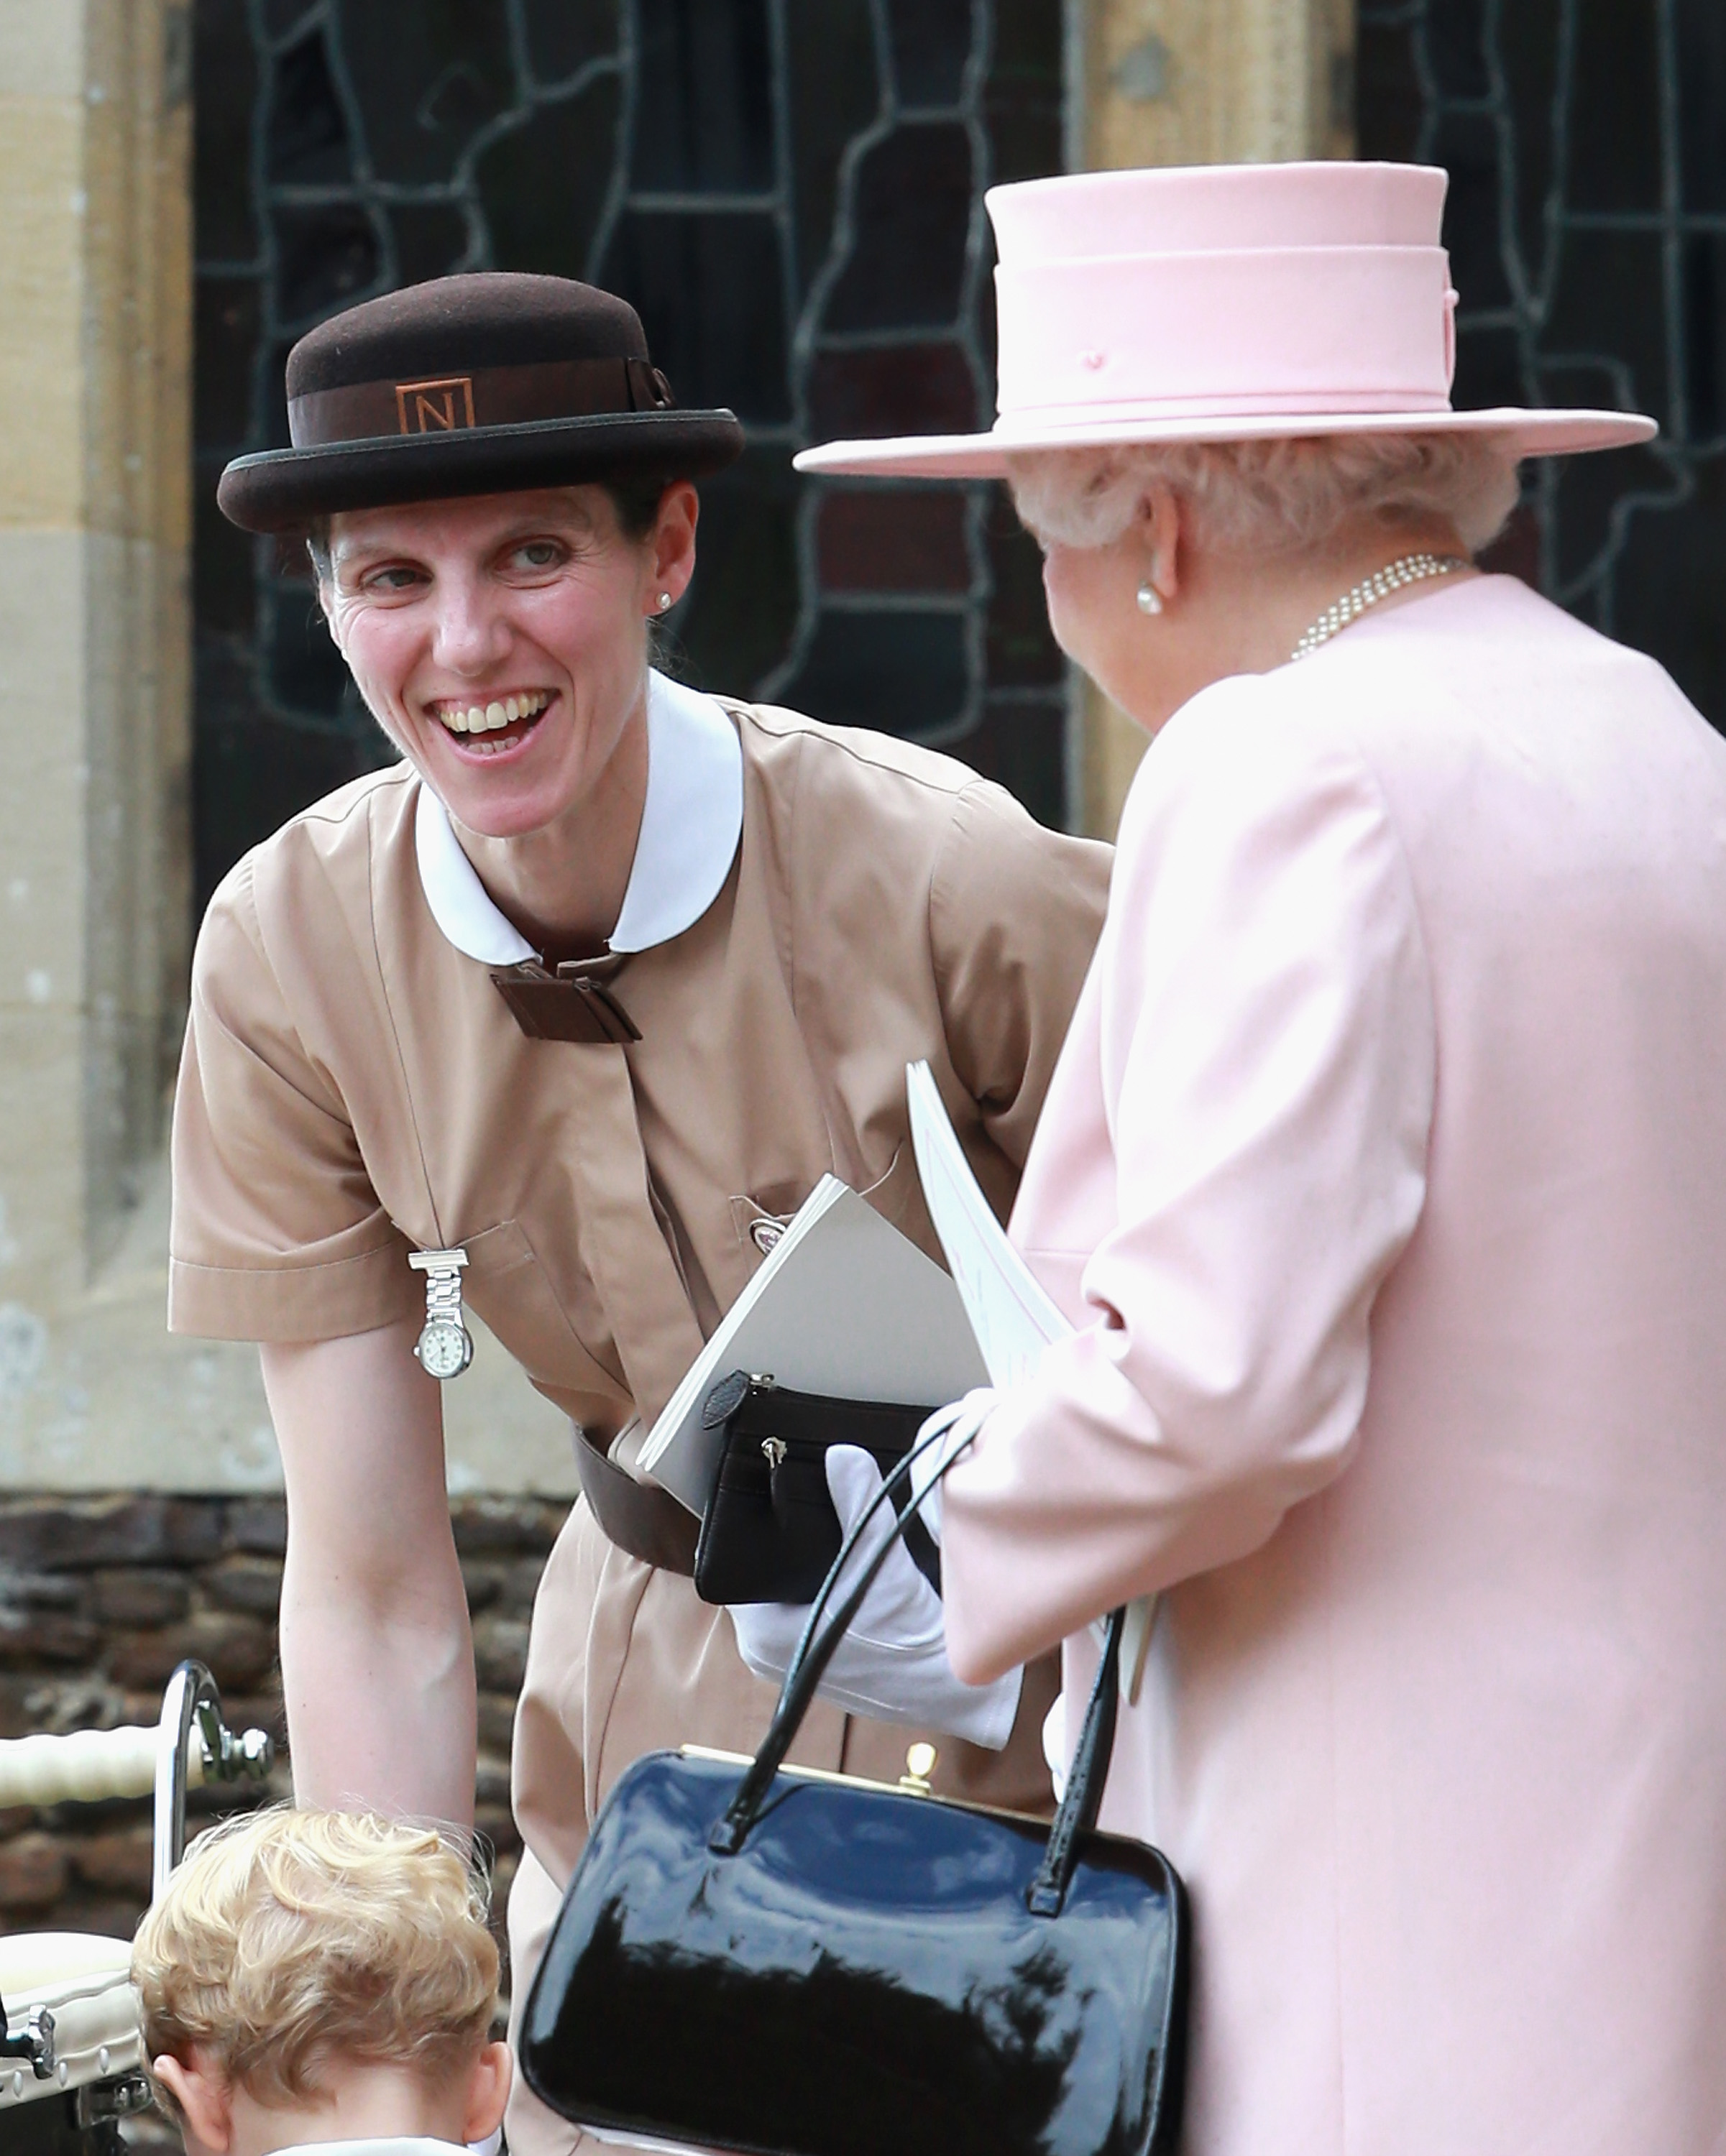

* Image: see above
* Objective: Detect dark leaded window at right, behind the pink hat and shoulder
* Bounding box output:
[1359,0,1726,727]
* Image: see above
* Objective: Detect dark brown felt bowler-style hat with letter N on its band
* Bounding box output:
[216,270,742,533]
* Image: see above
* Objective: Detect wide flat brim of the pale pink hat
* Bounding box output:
[791,407,1659,479]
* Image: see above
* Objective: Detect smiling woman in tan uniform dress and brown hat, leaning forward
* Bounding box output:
[170,276,1109,2156]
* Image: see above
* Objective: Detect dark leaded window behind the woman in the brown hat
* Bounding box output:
[194,0,1066,899]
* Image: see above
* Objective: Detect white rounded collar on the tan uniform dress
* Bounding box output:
[414,673,742,966]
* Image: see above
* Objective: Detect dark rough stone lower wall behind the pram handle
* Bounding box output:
[0,1494,565,1966]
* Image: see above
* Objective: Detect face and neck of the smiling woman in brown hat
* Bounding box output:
[319,481,697,957]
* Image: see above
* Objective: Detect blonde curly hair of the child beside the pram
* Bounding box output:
[132,1807,498,2106]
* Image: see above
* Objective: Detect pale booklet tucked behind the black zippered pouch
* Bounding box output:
[636,1175,991,1514]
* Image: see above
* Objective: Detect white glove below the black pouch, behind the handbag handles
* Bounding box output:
[731,1445,1021,1751]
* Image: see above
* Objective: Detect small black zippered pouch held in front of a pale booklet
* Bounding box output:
[694,1369,941,1602]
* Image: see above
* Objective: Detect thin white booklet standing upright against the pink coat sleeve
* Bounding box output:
[904,1063,1157,1705]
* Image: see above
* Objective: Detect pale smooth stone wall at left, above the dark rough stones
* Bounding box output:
[0,0,569,1494]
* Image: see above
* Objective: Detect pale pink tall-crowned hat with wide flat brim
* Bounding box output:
[796,164,1657,479]
